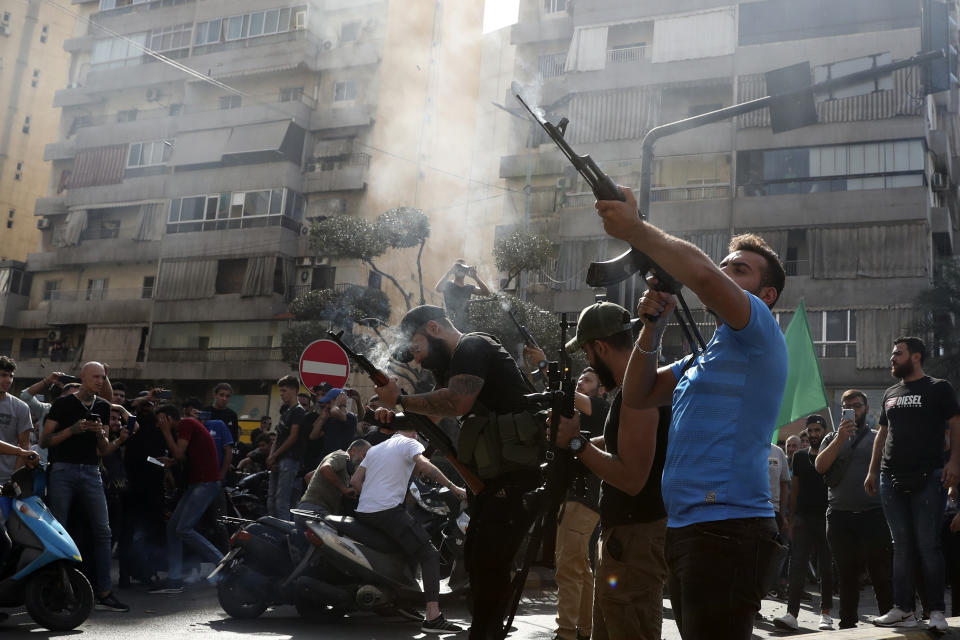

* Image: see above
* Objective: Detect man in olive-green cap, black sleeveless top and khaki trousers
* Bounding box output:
[557,302,670,640]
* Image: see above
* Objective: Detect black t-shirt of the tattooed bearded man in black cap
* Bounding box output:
[439,333,530,414]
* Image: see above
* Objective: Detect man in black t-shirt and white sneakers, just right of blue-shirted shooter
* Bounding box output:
[773,415,833,631]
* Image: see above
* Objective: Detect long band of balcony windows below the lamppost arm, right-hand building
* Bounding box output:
[737,140,926,196]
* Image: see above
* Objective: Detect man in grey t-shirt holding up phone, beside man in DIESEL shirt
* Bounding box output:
[816,389,893,629]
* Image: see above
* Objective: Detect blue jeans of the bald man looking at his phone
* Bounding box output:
[47,462,111,594]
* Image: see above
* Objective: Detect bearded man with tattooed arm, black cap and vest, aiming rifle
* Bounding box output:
[377,305,543,640]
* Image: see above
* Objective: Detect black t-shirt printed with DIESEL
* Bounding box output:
[879,376,960,472]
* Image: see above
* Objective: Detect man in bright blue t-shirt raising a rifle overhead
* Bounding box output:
[597,189,787,640]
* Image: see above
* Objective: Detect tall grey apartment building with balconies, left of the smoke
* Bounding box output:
[0,0,479,414]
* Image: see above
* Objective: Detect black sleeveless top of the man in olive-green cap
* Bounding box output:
[600,389,670,528]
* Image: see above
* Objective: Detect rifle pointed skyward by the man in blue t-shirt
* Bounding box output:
[511,82,706,353]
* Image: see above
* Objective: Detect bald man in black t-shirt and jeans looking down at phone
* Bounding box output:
[40,362,130,611]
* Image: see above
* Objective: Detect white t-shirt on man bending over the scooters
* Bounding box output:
[357,433,423,513]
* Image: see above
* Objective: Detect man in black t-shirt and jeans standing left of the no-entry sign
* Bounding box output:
[267,376,309,520]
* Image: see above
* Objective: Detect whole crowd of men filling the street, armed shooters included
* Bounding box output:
[0,189,960,640]
